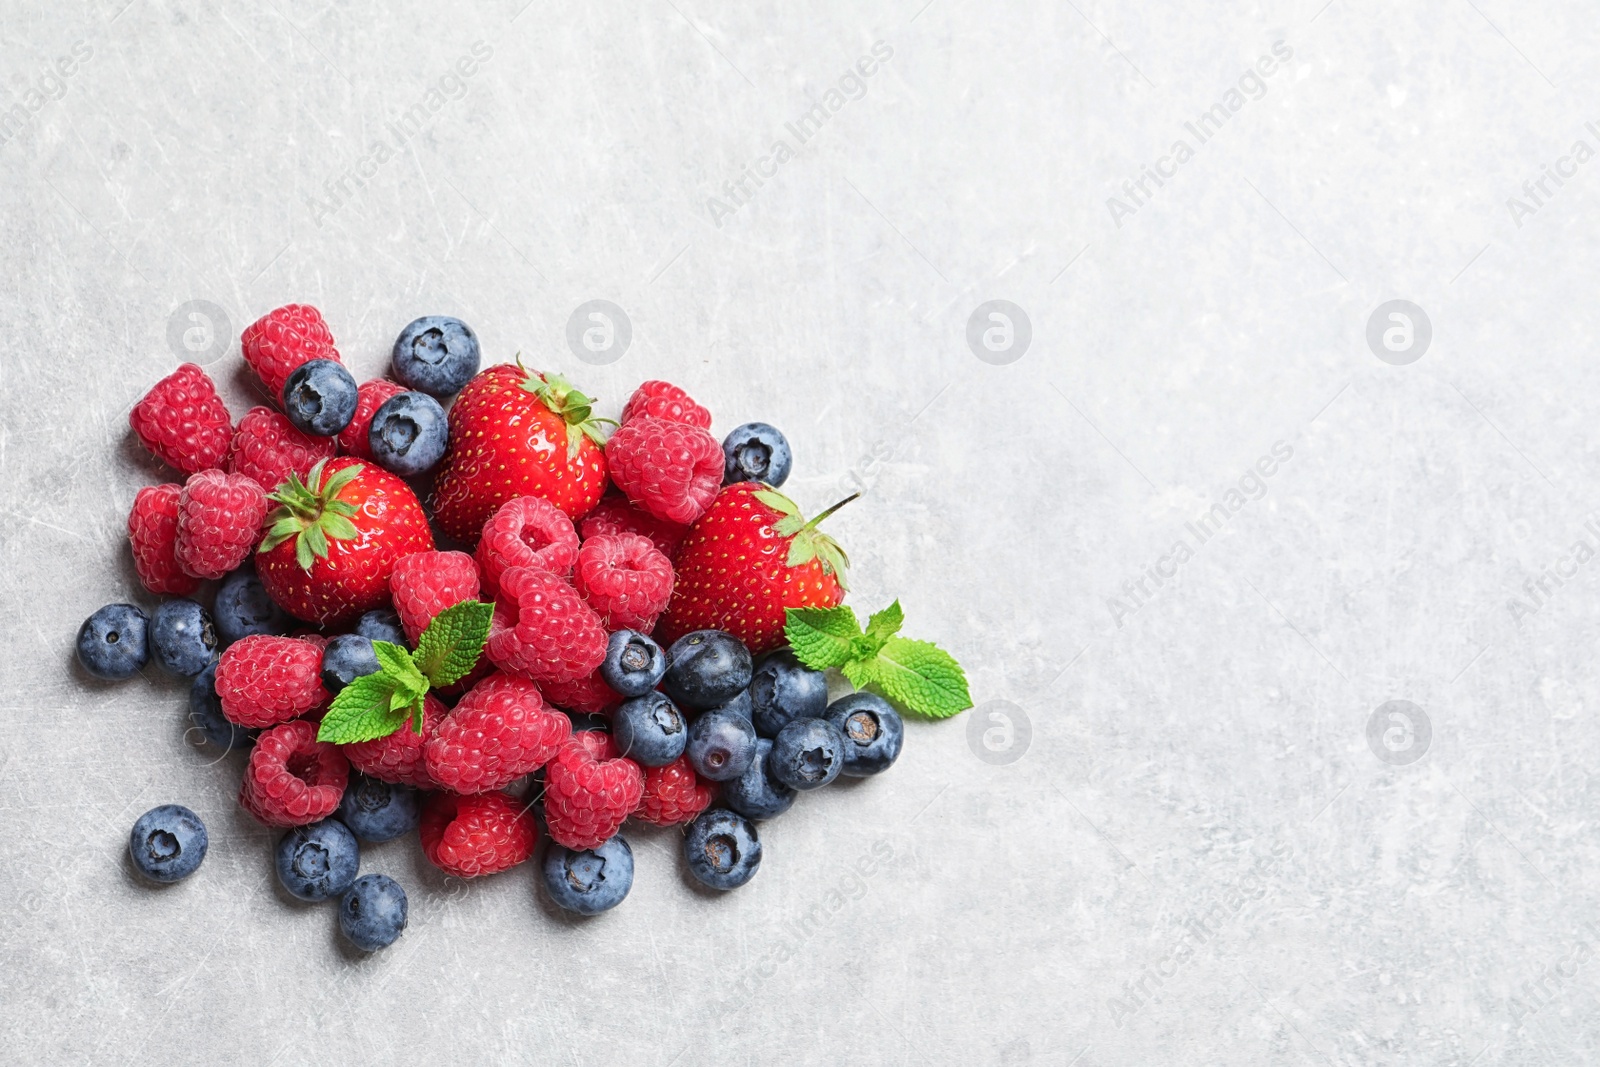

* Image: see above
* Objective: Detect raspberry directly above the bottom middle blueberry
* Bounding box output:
[544,729,645,851]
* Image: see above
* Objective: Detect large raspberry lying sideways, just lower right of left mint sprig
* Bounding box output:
[426,673,573,793]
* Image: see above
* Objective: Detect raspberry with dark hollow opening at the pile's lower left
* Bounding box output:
[238,720,350,825]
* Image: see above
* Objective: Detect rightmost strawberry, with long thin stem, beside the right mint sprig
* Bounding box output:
[654,482,854,654]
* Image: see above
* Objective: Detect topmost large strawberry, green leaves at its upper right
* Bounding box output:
[432,363,606,544]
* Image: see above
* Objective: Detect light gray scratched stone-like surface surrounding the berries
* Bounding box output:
[0,0,1600,1067]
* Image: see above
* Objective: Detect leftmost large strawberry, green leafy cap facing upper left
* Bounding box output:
[256,456,434,625]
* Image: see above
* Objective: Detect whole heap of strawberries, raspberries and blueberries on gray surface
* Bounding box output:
[77,306,965,950]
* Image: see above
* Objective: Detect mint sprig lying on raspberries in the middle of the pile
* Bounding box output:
[308,600,494,744]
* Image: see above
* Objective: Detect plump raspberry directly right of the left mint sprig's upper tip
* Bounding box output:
[485,566,606,681]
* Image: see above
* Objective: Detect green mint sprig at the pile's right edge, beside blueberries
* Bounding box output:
[784,600,973,718]
